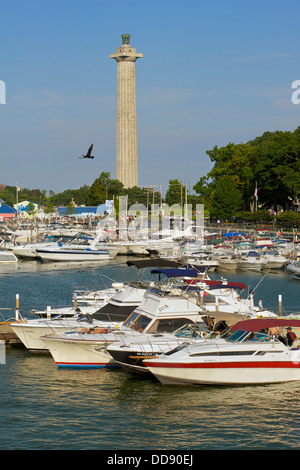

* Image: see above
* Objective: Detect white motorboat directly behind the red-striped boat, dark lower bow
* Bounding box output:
[107,279,277,374]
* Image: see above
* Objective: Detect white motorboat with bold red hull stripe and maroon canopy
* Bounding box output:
[144,317,300,385]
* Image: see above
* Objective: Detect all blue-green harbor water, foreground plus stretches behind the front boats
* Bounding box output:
[0,258,300,451]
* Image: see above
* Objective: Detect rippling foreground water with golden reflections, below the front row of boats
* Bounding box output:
[0,351,300,450]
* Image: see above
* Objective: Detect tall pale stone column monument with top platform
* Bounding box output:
[109,34,143,188]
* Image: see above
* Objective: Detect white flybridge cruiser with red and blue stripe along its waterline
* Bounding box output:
[40,269,210,368]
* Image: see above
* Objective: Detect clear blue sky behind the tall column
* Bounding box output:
[0,0,300,192]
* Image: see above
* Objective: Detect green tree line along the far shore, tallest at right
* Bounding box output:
[0,126,300,219]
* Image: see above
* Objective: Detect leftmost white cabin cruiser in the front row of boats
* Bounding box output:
[11,259,185,351]
